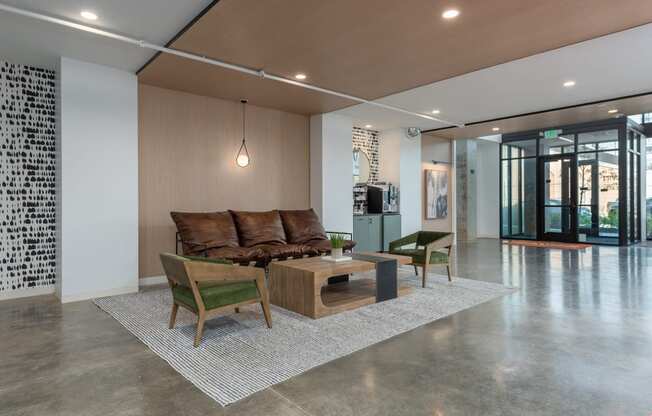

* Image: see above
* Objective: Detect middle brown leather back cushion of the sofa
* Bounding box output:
[230,210,286,247]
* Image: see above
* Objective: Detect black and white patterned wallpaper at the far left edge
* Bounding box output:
[0,61,57,295]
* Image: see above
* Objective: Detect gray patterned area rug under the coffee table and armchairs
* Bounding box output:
[94,268,515,406]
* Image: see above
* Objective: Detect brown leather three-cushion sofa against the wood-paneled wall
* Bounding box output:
[170,209,355,266]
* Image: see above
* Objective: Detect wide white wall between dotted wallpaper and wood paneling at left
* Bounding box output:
[57,58,138,302]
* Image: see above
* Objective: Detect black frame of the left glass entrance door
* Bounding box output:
[537,153,578,243]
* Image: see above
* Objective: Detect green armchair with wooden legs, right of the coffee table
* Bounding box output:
[389,231,455,287]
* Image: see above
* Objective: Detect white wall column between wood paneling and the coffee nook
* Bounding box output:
[310,113,353,232]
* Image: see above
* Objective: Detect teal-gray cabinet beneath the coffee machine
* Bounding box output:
[353,214,401,252]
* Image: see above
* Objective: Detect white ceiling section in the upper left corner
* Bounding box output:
[0,0,211,72]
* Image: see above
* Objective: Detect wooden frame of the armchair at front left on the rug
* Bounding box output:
[161,253,272,347]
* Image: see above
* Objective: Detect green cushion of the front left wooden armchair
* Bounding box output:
[172,282,258,310]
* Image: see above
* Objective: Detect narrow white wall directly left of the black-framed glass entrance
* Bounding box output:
[475,139,500,238]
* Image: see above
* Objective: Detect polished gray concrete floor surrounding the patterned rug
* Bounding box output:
[0,240,652,416]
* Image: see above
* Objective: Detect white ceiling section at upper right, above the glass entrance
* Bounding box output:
[336,24,652,130]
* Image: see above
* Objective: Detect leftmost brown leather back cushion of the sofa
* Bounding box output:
[170,212,238,255]
